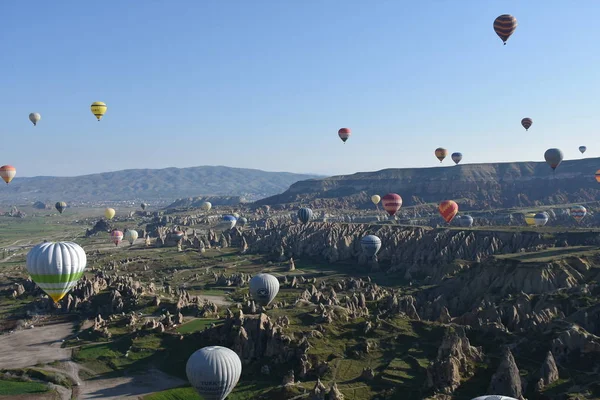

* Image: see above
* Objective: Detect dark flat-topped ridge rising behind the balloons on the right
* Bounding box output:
[256,158,600,209]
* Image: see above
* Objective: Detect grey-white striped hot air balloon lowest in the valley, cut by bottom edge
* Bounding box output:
[185,346,242,400]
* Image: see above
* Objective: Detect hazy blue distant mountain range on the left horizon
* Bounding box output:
[0,166,319,204]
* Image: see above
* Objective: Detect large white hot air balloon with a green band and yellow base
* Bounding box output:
[26,242,87,303]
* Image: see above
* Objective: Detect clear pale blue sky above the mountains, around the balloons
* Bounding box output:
[0,0,600,176]
